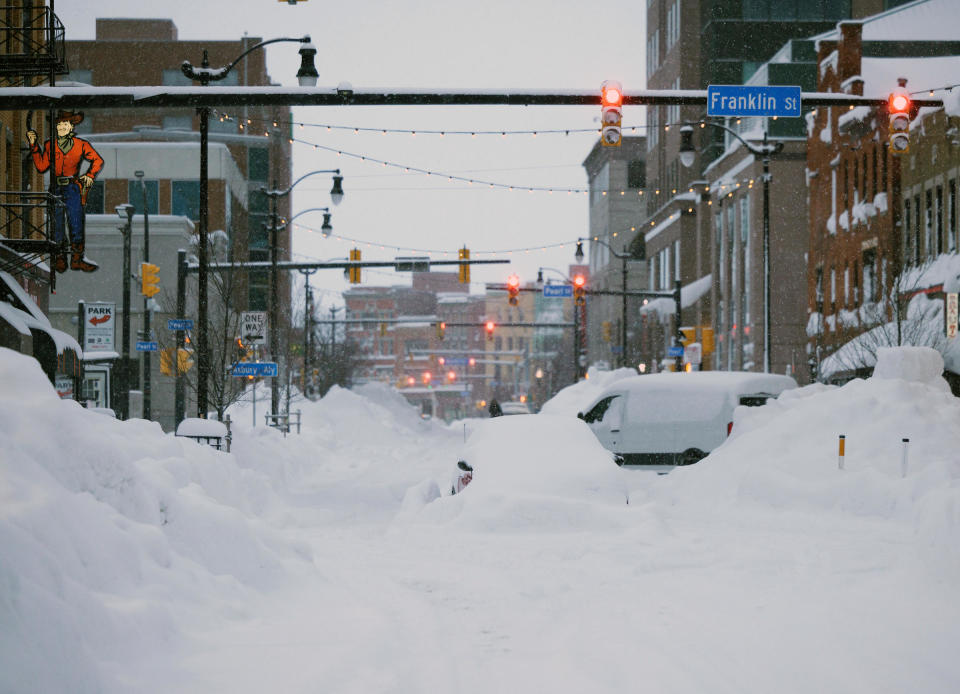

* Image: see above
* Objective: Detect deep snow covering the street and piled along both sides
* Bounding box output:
[0,350,960,694]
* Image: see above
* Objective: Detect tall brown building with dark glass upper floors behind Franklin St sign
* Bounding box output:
[641,0,884,371]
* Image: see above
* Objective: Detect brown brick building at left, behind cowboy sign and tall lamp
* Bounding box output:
[66,18,291,320]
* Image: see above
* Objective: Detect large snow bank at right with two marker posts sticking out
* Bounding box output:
[657,347,960,566]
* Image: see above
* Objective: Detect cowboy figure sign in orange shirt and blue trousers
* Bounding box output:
[27,111,103,272]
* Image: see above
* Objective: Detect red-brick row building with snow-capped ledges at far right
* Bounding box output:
[807,0,960,378]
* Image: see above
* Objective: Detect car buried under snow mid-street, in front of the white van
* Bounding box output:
[450,414,629,504]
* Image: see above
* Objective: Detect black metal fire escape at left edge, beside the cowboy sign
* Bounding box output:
[0,0,68,291]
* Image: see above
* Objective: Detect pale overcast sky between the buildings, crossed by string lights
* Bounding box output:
[55,0,646,303]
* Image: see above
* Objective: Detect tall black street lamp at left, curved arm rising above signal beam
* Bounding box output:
[180,36,319,418]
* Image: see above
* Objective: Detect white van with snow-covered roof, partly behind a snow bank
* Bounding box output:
[577,371,797,465]
